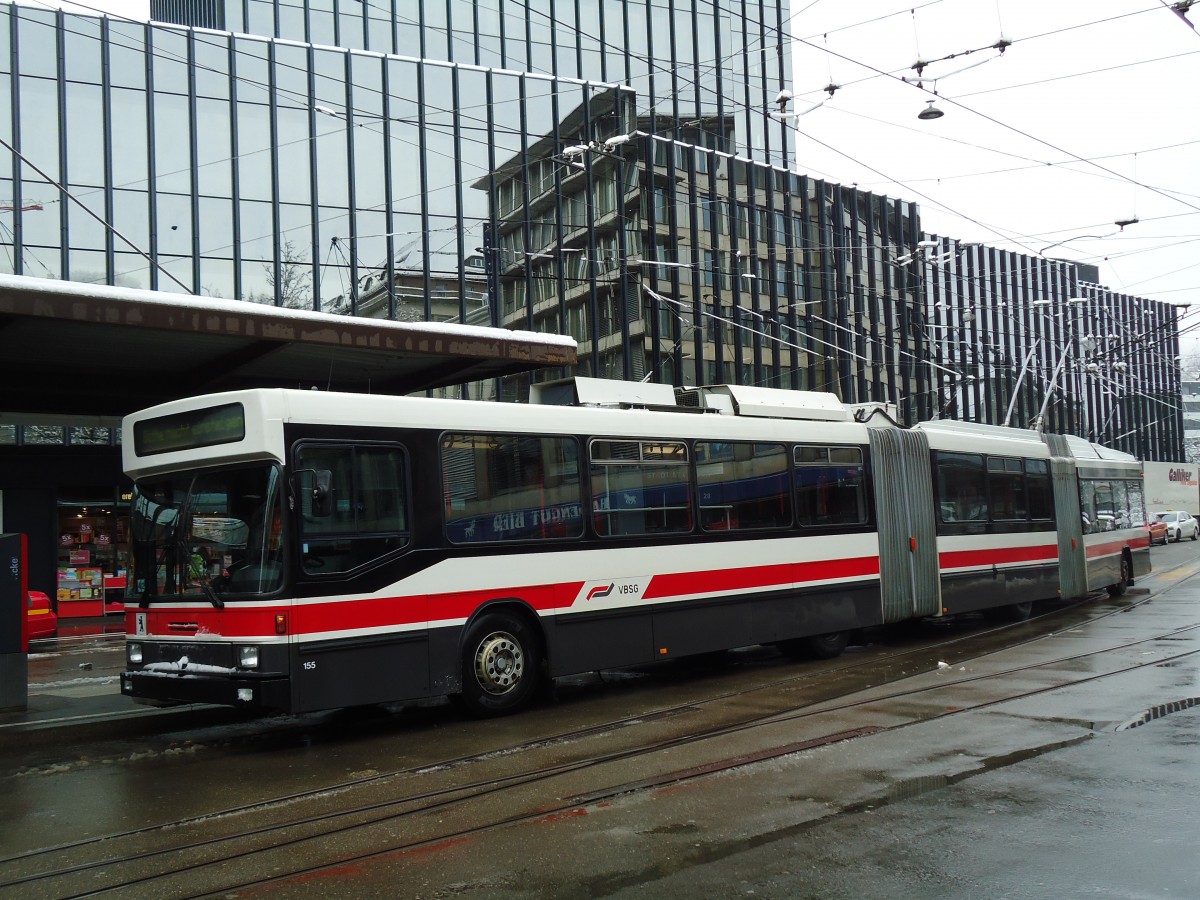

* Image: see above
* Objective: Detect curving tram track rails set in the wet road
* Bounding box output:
[0,566,1200,896]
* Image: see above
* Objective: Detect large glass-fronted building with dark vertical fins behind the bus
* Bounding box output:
[0,0,1182,458]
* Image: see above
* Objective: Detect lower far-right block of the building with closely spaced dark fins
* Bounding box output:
[917,243,1183,460]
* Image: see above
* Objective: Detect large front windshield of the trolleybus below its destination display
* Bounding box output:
[130,464,286,605]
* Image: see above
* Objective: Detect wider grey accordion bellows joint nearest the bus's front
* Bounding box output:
[870,426,942,622]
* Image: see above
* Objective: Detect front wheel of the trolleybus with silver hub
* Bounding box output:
[457,612,541,718]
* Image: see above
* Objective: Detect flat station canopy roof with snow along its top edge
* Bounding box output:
[0,275,577,422]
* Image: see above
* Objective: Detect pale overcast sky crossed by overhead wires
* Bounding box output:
[791,0,1200,362]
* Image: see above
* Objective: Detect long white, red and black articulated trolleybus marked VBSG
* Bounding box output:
[121,378,1150,715]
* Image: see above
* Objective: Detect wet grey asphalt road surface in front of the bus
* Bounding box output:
[0,544,1200,898]
